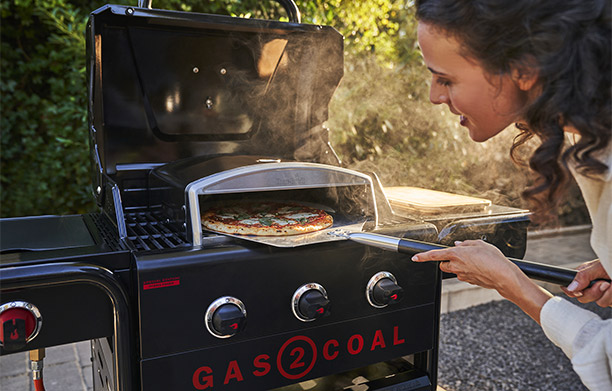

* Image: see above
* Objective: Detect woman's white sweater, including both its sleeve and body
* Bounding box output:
[540,142,612,391]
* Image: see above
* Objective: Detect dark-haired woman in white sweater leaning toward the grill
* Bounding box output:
[413,0,612,390]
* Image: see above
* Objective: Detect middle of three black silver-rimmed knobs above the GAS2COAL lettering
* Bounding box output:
[291,282,331,322]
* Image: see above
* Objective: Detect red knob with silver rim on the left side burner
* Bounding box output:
[0,301,42,352]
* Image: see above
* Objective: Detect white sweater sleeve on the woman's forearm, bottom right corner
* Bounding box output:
[540,297,612,391]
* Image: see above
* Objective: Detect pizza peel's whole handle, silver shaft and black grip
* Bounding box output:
[347,232,610,286]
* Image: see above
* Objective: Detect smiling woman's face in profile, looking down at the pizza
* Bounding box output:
[418,22,527,142]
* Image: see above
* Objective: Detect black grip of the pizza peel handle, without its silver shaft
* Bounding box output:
[397,239,610,286]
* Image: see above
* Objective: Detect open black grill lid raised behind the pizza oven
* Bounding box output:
[88,5,343,203]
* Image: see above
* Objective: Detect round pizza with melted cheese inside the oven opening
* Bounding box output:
[202,201,334,236]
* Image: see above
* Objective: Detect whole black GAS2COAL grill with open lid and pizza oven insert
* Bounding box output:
[0,0,528,391]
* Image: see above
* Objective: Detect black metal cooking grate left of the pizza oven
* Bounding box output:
[125,211,190,251]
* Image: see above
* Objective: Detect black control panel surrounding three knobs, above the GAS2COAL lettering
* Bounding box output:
[137,242,439,359]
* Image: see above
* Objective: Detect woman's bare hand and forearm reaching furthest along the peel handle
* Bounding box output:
[412,240,552,323]
